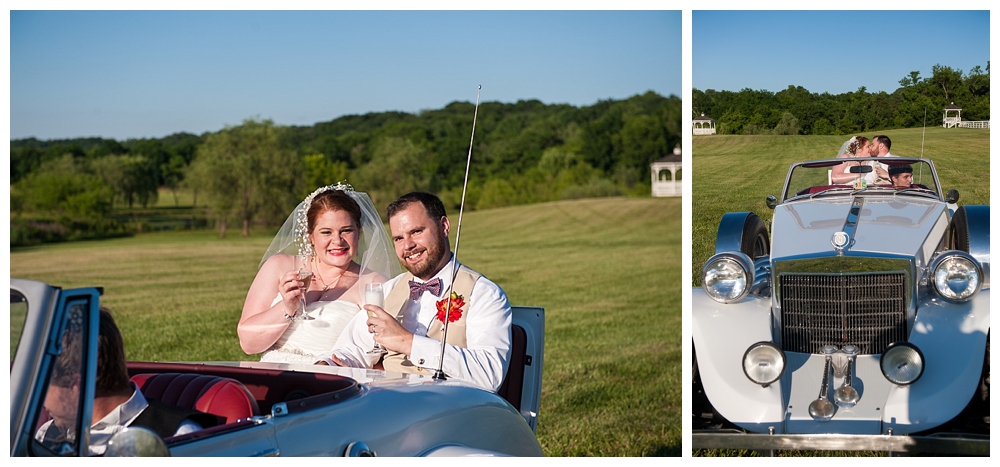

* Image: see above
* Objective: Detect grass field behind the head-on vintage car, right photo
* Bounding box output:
[691,127,990,286]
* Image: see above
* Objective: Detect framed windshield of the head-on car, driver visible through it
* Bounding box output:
[783,157,941,201]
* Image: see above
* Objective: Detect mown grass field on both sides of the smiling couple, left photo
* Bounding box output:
[10,198,682,456]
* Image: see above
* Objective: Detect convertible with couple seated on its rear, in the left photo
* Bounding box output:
[10,279,545,457]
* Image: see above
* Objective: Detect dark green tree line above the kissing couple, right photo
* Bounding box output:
[691,61,990,135]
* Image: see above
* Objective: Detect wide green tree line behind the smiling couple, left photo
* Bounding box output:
[10,91,681,245]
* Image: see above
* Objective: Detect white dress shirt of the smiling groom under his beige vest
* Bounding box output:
[326,261,511,392]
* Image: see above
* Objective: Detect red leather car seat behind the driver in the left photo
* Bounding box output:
[132,373,260,423]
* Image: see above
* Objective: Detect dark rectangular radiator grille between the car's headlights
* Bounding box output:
[779,273,906,354]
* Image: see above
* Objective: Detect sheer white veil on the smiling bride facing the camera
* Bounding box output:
[257,183,402,284]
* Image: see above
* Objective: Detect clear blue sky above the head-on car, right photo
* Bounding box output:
[691,10,990,94]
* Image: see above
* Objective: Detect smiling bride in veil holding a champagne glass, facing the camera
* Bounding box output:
[237,183,400,364]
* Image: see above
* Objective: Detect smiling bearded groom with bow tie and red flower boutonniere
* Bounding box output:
[324,192,511,391]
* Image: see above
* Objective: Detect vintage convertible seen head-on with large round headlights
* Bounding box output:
[690,157,990,455]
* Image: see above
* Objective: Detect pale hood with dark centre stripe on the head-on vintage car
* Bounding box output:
[771,195,948,260]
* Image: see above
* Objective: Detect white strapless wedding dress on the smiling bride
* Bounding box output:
[260,295,361,364]
